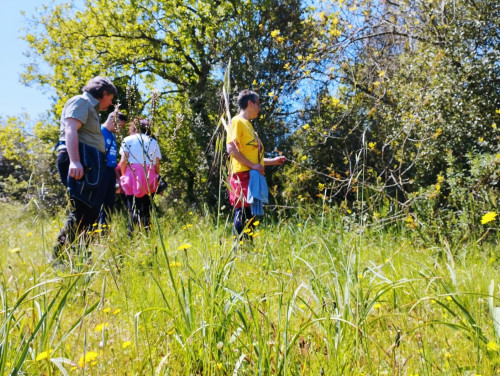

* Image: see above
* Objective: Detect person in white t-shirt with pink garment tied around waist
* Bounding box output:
[120,119,161,235]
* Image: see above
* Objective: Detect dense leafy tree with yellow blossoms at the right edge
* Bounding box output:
[282,0,500,212]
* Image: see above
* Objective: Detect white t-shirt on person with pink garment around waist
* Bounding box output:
[120,133,161,165]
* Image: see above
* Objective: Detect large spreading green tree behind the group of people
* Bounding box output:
[24,0,328,206]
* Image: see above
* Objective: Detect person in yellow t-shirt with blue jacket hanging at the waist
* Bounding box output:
[226,90,286,235]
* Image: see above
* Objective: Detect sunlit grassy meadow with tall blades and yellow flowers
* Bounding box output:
[0,203,500,376]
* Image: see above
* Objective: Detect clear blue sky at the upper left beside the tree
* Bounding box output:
[0,0,56,119]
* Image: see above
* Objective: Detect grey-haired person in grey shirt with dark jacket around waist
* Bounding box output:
[51,76,117,261]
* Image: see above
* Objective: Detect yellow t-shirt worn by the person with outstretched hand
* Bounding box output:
[226,115,264,172]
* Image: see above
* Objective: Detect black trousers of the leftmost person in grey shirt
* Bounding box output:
[54,150,102,256]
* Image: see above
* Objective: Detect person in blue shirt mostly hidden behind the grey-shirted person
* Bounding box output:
[99,111,127,227]
